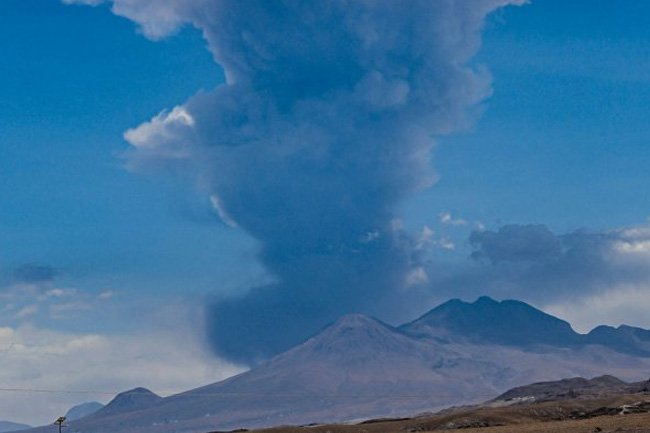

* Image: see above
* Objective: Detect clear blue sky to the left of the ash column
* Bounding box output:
[0,0,260,326]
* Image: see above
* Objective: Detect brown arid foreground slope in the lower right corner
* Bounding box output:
[234,376,650,433]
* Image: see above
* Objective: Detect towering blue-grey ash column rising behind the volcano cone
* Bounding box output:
[67,0,523,363]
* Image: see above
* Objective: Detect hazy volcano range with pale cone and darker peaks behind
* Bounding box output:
[22,298,650,433]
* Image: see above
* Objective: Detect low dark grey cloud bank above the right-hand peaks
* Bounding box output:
[429,224,650,304]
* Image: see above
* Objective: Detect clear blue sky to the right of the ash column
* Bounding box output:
[408,1,650,231]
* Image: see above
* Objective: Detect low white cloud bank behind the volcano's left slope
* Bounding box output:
[0,325,246,424]
